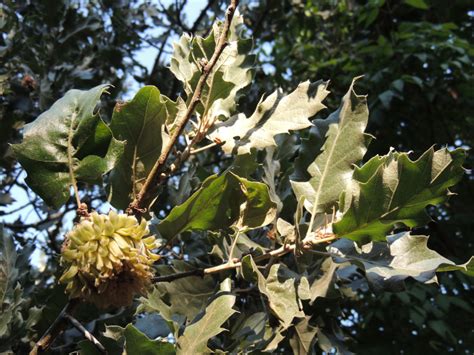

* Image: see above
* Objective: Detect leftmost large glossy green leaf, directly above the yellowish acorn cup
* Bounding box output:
[12,85,124,208]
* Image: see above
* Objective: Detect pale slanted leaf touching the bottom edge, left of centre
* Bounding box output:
[177,284,236,354]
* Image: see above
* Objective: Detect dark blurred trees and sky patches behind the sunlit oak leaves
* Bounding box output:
[0,0,474,353]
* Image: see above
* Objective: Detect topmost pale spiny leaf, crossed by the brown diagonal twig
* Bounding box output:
[170,14,255,119]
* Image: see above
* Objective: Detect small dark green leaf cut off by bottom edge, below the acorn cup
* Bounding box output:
[123,324,176,355]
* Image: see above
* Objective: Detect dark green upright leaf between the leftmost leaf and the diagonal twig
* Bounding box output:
[107,86,176,209]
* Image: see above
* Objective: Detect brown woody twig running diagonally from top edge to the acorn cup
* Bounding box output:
[127,0,238,216]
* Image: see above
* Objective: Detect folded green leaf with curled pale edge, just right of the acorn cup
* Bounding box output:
[157,171,276,239]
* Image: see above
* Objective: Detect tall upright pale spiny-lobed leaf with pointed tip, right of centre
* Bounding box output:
[291,78,370,214]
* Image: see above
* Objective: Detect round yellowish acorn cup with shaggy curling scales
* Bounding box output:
[59,211,159,308]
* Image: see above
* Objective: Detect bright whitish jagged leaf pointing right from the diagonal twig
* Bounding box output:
[210,81,329,155]
